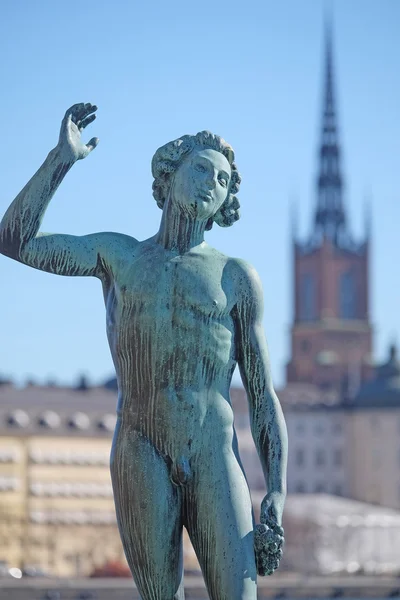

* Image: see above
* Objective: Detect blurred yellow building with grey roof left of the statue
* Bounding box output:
[0,385,123,576]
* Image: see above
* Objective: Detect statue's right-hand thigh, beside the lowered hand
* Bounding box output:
[187,449,257,600]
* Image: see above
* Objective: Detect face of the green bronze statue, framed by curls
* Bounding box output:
[173,148,231,219]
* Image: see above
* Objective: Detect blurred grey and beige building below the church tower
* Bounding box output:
[278,345,400,510]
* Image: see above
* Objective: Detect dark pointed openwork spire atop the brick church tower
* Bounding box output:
[315,21,346,244]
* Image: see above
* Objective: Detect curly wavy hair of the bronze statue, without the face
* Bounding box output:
[151,131,241,229]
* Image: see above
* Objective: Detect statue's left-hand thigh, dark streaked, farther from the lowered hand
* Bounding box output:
[111,431,182,600]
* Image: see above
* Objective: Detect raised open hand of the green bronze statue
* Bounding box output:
[57,102,99,162]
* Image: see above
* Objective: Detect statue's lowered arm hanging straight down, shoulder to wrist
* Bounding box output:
[234,261,288,575]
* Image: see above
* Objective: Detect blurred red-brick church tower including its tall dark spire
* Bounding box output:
[286,25,372,397]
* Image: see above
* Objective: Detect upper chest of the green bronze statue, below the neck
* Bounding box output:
[116,256,229,318]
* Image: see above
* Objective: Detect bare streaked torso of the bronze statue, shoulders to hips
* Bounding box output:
[105,242,239,455]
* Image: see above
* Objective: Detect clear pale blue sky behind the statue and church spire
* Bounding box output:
[0,0,400,386]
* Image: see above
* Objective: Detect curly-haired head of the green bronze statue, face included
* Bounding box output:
[151,131,240,229]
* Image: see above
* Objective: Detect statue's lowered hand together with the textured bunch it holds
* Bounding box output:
[254,492,284,575]
